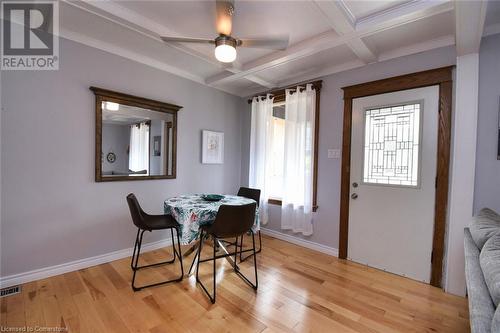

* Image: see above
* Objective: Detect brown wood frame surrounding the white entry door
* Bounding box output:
[339,66,455,288]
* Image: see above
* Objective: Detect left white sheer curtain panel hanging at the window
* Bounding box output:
[248,95,273,224]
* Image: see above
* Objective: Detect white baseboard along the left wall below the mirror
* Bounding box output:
[0,238,172,288]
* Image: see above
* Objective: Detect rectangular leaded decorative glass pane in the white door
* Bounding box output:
[363,103,422,187]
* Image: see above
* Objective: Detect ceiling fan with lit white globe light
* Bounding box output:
[161,0,288,63]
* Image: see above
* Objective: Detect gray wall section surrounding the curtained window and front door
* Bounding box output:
[241,47,456,248]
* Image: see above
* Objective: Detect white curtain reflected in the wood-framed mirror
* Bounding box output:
[128,122,149,173]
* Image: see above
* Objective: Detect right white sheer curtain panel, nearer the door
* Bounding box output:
[281,84,316,236]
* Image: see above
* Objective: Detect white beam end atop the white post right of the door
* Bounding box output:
[455,0,488,56]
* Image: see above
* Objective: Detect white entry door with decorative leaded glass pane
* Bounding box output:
[347,86,439,283]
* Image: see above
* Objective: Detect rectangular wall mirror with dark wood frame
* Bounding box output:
[90,87,182,182]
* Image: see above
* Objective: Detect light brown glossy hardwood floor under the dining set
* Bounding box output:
[0,237,469,333]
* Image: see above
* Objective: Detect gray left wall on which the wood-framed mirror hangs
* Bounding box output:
[1,39,244,276]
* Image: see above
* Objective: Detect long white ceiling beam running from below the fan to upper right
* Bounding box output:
[205,0,454,84]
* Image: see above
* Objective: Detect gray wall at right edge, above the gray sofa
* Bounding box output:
[474,34,500,212]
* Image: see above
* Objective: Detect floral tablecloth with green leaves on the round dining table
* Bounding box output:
[164,194,260,245]
